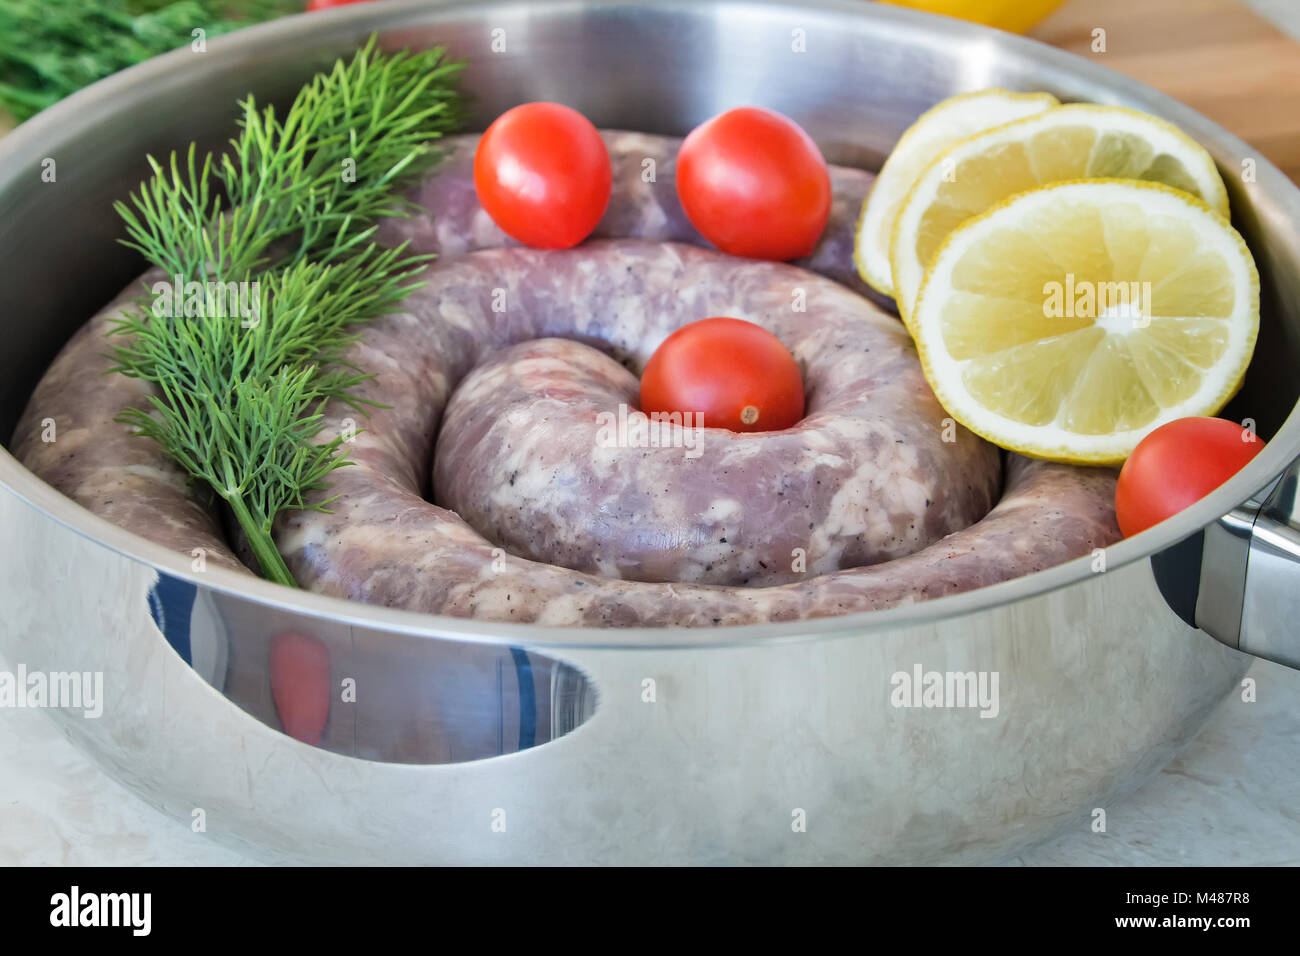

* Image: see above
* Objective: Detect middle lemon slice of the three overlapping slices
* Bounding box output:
[889,104,1229,329]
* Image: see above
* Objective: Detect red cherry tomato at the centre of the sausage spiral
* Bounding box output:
[641,316,803,432]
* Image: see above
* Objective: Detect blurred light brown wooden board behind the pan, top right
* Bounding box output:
[1030,0,1300,182]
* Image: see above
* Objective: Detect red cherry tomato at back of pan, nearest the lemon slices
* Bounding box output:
[677,107,831,260]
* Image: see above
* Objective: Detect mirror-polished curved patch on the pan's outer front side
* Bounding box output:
[193,575,595,763]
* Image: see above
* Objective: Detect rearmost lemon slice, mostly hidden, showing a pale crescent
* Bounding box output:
[853,90,1057,295]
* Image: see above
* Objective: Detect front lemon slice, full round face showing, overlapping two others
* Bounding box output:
[913,179,1260,464]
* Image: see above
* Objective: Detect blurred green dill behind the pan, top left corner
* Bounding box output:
[0,0,303,121]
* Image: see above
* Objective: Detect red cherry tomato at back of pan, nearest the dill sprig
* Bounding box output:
[475,103,614,248]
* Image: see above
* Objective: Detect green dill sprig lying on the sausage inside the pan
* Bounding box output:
[113,38,462,585]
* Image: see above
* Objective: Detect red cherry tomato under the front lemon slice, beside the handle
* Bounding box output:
[1115,418,1264,537]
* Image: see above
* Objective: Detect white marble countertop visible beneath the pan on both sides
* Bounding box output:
[0,650,1300,866]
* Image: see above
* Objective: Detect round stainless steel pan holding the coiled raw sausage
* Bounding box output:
[0,0,1300,862]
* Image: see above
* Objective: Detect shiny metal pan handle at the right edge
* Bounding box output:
[1184,459,1300,669]
